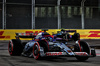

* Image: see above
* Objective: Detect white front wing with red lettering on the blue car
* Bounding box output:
[40,47,96,57]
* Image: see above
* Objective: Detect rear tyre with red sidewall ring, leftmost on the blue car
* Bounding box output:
[8,39,23,56]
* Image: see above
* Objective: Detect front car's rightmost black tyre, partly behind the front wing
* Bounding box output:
[74,41,90,61]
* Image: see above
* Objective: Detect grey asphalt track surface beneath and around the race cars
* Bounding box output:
[0,40,100,66]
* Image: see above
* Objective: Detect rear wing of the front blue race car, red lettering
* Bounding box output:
[15,33,38,39]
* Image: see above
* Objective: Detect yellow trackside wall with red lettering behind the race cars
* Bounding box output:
[0,29,100,40]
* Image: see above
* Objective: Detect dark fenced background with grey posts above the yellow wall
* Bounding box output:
[0,0,100,29]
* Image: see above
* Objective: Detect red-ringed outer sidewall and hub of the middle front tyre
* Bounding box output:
[33,42,40,60]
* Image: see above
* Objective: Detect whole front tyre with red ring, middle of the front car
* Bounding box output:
[33,40,49,60]
